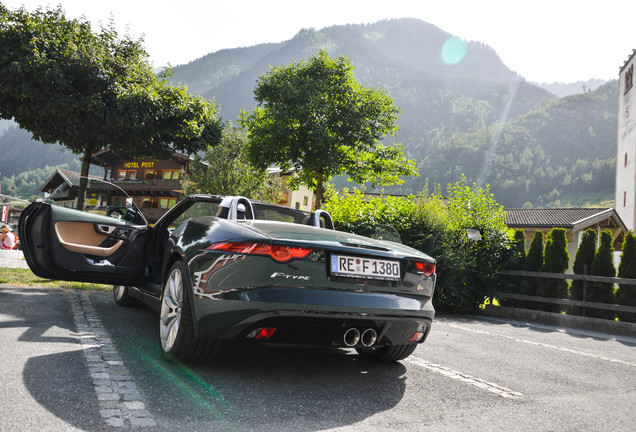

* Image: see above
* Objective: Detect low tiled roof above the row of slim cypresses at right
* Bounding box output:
[506,208,627,231]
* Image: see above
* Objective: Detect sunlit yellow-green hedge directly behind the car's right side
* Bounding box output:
[323,180,513,313]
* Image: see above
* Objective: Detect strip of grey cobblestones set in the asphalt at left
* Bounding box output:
[70,290,157,427]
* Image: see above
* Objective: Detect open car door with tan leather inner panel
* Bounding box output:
[19,203,149,285]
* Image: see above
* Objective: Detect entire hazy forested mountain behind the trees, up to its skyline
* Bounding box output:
[0,19,618,207]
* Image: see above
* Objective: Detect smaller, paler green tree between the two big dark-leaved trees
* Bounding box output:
[183,123,276,198]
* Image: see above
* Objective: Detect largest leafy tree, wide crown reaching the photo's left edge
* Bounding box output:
[0,4,220,206]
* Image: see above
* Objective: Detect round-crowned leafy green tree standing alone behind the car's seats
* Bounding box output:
[241,51,416,208]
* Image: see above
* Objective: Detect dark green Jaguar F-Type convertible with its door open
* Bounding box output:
[19,195,436,362]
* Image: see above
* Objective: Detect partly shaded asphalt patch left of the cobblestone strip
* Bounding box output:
[0,285,103,430]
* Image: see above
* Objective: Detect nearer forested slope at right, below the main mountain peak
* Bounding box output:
[414,81,618,208]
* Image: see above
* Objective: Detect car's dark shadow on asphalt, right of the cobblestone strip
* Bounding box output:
[93,290,407,431]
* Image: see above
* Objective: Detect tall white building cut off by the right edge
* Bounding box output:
[614,50,636,230]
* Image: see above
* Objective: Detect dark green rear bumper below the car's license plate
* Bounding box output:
[194,287,435,346]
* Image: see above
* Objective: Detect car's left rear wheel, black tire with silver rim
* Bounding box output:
[159,261,215,363]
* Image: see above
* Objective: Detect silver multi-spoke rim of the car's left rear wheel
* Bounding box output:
[159,268,183,352]
